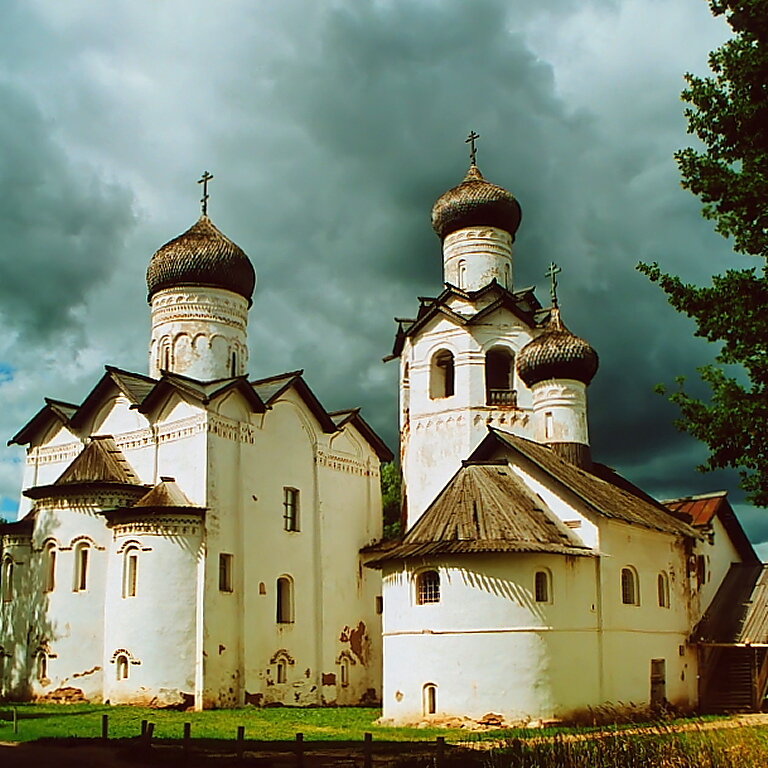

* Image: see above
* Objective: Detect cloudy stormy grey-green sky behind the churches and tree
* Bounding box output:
[0,0,768,555]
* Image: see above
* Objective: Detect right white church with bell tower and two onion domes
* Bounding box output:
[366,152,768,723]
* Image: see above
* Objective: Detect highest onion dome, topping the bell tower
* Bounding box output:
[432,164,522,239]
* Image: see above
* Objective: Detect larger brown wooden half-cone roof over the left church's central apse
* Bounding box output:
[24,436,146,499]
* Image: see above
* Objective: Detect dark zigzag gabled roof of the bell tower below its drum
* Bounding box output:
[384,279,547,362]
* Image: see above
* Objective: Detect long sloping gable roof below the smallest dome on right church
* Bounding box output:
[470,427,700,538]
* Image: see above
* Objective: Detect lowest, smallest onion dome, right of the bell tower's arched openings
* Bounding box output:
[517,307,598,387]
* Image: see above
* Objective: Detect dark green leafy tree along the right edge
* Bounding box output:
[638,0,768,506]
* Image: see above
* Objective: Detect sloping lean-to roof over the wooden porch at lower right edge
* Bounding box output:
[692,563,768,645]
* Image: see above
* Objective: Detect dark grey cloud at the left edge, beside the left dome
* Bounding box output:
[0,81,133,337]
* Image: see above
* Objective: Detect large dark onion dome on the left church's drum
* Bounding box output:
[147,214,256,302]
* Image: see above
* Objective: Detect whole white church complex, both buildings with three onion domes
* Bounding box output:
[0,147,768,723]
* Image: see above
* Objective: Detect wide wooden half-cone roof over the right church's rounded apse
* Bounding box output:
[368,461,595,565]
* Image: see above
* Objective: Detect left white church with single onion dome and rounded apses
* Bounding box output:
[0,204,391,708]
